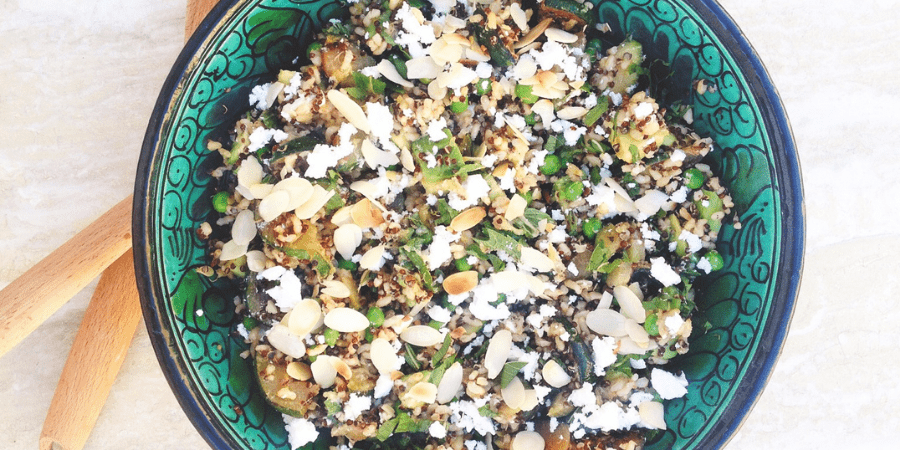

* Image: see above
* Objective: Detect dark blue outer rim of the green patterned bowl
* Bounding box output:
[132,0,806,450]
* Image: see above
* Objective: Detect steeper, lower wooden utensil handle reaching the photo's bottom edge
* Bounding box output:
[40,250,141,450]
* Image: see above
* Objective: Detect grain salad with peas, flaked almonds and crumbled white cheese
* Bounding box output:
[198,0,732,450]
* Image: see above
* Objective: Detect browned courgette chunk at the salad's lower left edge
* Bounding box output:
[255,353,319,417]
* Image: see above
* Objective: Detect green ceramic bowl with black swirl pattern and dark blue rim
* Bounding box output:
[134,0,804,450]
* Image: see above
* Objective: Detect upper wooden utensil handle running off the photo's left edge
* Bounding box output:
[0,196,131,356]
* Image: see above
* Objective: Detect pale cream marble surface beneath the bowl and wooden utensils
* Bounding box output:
[0,0,900,450]
